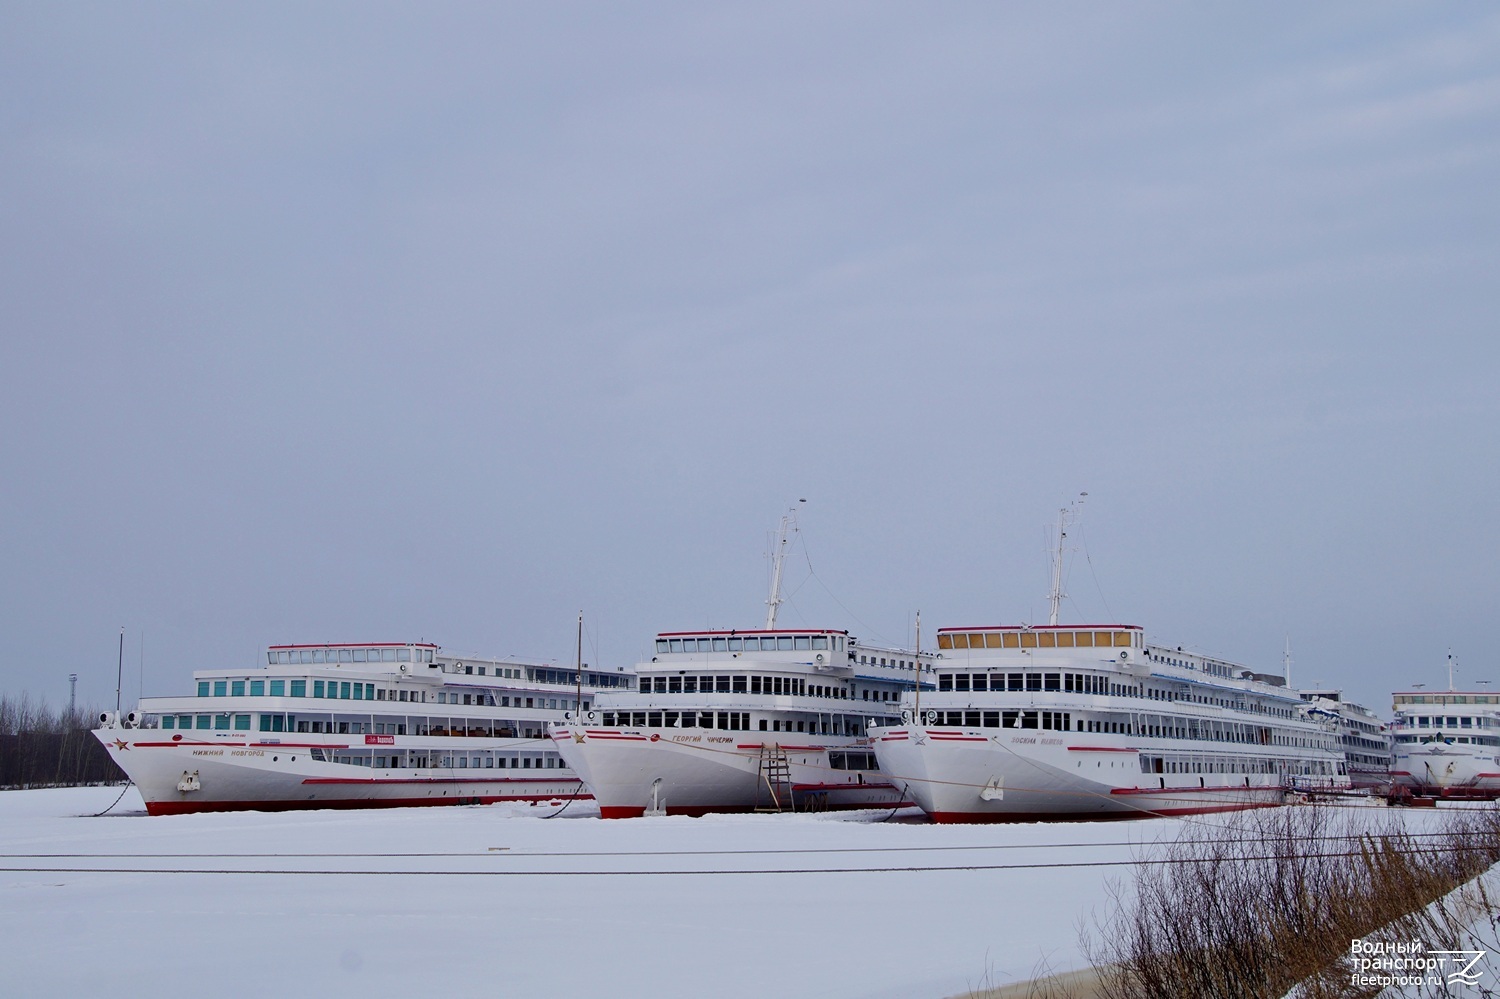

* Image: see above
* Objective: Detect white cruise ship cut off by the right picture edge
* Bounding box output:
[1391,659,1500,798]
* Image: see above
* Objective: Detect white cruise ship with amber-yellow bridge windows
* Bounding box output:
[873,624,1349,822]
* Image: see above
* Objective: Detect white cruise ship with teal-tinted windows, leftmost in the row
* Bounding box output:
[95,642,633,815]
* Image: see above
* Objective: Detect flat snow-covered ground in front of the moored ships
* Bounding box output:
[0,788,1179,999]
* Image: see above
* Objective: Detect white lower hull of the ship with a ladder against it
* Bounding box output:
[552,726,911,819]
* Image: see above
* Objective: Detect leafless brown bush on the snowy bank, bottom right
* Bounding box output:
[1083,807,1500,999]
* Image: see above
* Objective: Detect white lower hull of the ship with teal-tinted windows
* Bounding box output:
[95,728,588,815]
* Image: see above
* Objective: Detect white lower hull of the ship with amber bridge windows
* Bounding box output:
[875,726,1296,822]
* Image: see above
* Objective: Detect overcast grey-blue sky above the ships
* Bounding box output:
[0,3,1500,711]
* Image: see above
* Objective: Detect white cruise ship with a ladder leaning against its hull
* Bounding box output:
[552,629,930,819]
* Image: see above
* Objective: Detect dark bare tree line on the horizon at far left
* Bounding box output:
[0,693,126,789]
